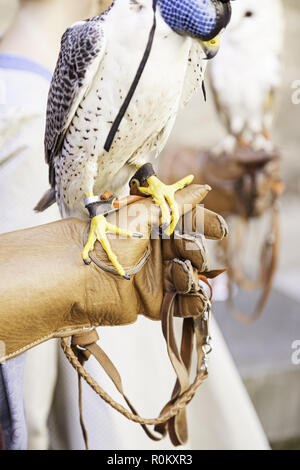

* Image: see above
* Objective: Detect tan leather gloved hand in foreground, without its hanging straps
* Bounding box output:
[0,185,227,361]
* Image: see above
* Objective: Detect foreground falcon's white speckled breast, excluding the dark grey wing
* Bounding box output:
[54,1,206,218]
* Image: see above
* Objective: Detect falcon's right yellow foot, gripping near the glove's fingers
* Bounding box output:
[139,175,194,236]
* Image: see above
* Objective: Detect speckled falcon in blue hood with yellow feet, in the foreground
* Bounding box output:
[36,0,231,279]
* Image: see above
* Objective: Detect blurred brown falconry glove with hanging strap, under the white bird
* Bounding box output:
[161,145,284,322]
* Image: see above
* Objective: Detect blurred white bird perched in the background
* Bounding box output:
[210,0,284,153]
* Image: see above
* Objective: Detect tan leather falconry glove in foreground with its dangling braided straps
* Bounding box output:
[0,185,227,445]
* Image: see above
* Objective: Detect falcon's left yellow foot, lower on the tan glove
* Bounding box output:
[82,215,142,280]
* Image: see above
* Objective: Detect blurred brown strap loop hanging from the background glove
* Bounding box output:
[222,203,280,323]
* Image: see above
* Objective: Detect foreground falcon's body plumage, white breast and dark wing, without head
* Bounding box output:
[45,0,220,219]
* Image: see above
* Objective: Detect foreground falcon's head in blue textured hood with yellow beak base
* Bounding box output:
[157,0,231,59]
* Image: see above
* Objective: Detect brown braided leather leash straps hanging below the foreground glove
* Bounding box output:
[62,292,210,449]
